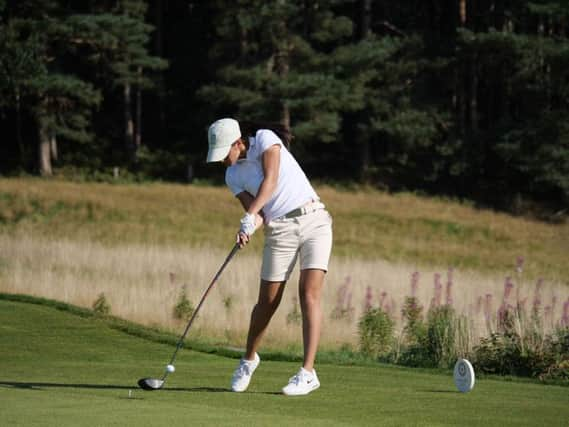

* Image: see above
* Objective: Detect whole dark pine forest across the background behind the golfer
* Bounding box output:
[0,0,569,215]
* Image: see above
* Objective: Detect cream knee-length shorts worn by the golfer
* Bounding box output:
[261,209,332,282]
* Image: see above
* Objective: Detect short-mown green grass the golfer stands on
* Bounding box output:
[0,300,569,426]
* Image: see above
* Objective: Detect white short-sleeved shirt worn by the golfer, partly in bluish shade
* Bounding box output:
[225,129,319,222]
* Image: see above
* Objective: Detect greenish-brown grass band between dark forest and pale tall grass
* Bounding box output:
[0,178,569,282]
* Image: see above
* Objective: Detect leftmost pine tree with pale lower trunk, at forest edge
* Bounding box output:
[0,0,100,175]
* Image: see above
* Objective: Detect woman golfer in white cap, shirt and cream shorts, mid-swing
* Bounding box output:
[207,119,332,396]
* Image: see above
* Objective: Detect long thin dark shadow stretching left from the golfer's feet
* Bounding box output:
[0,381,281,395]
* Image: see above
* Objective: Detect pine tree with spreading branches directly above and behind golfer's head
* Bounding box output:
[200,0,352,152]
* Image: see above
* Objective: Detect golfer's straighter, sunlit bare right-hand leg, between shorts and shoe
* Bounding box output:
[298,269,326,371]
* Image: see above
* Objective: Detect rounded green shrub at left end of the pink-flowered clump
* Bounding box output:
[358,308,394,358]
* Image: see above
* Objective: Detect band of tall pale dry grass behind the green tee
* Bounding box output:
[0,233,569,354]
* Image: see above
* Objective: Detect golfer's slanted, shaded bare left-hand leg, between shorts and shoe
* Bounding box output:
[245,280,286,360]
